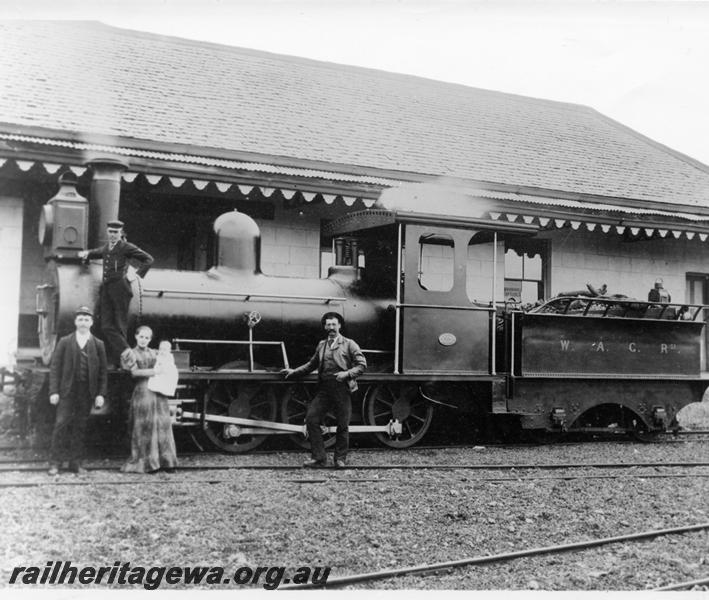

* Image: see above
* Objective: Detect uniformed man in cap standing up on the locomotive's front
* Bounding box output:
[79,221,153,366]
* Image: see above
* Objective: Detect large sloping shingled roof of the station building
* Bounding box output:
[0,21,709,207]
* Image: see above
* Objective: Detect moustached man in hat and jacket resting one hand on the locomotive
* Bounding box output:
[282,312,367,469]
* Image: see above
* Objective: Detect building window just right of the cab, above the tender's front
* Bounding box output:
[505,240,549,304]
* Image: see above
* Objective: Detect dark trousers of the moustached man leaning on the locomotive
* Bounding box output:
[305,380,352,460]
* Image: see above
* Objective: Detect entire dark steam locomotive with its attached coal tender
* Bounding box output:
[37,173,705,452]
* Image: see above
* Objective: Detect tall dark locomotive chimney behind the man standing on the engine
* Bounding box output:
[88,158,126,248]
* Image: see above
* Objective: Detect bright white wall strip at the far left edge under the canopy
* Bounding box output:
[0,197,23,366]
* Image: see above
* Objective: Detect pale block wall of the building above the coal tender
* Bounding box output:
[544,230,709,302]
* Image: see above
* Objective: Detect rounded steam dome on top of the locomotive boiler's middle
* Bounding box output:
[214,210,261,273]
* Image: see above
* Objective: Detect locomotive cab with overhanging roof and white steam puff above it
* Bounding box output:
[326,187,537,378]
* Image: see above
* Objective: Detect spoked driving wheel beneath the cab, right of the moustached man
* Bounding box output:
[363,384,433,448]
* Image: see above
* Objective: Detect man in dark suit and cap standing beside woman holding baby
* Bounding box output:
[49,306,108,475]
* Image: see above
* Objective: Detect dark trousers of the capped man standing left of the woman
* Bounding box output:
[49,381,92,465]
